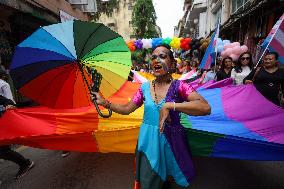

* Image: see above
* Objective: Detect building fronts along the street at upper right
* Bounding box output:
[179,0,284,59]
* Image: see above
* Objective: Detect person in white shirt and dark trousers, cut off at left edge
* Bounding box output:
[0,70,34,179]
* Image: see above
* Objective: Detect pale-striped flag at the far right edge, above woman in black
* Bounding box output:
[261,14,284,64]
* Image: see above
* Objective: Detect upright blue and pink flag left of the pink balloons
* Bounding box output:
[199,24,220,69]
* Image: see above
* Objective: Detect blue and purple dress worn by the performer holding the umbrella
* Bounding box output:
[135,80,194,189]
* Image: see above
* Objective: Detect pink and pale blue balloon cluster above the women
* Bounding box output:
[217,38,248,61]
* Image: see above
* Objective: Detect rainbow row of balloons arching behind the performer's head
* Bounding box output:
[126,37,192,52]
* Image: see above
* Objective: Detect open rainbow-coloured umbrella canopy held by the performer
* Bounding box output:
[10,20,131,108]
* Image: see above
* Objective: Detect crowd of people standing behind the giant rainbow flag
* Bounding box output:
[130,52,284,107]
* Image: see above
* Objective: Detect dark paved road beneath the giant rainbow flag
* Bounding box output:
[0,147,284,189]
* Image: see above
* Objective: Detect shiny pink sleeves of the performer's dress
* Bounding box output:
[131,81,194,107]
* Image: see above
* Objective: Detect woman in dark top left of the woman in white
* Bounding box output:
[216,57,233,81]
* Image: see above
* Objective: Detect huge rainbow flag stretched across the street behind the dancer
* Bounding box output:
[0,80,284,160]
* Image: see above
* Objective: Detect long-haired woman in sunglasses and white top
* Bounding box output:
[231,52,253,85]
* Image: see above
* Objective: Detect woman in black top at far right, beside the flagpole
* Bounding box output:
[244,52,284,106]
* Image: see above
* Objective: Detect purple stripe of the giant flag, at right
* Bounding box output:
[222,84,284,144]
